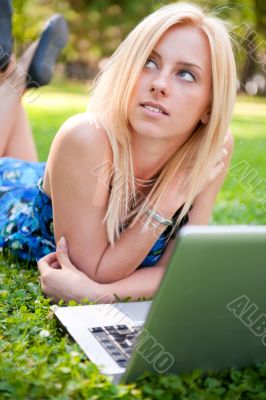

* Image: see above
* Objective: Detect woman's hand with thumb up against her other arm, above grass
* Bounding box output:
[38,238,100,301]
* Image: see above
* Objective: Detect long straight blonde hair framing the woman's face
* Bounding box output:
[88,3,236,244]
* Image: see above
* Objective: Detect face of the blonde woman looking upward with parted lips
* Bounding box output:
[128,25,212,142]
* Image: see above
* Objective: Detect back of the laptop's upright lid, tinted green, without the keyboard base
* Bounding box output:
[124,226,266,382]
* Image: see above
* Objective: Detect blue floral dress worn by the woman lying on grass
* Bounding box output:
[0,157,188,267]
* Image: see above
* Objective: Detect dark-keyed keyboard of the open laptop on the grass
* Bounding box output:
[89,325,142,368]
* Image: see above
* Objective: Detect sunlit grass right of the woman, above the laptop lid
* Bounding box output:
[213,97,266,225]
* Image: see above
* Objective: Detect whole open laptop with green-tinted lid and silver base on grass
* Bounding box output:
[55,226,266,383]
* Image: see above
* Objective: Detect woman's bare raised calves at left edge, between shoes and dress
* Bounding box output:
[0,42,38,161]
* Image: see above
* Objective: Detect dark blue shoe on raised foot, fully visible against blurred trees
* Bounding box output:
[27,14,68,88]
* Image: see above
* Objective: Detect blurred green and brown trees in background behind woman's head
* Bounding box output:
[13,0,266,86]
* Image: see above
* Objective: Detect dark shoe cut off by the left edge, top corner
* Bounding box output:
[0,0,12,72]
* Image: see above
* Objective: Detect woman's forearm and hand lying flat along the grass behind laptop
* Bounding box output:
[38,238,170,303]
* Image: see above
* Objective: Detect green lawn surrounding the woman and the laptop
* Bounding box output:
[0,83,266,400]
